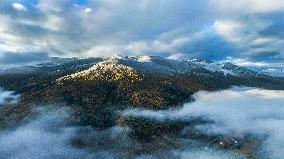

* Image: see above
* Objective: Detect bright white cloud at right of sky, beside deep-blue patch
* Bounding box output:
[213,17,284,60]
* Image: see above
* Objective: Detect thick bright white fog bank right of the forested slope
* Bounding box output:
[125,87,284,159]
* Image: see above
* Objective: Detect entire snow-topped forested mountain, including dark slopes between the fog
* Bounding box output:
[0,56,284,158]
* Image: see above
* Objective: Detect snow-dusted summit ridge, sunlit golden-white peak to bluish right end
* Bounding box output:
[55,55,262,79]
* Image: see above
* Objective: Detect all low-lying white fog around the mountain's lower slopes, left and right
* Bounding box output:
[0,87,284,159]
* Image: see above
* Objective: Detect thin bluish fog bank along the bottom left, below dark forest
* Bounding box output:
[0,105,244,159]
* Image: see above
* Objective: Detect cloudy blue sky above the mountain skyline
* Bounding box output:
[0,0,284,64]
